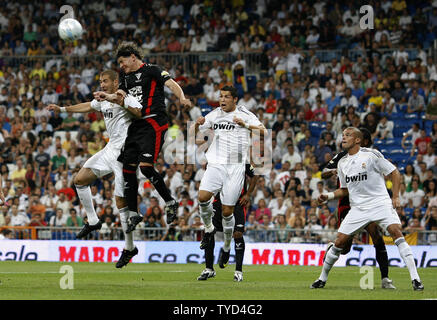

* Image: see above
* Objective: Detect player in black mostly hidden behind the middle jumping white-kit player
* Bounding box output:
[197,164,259,282]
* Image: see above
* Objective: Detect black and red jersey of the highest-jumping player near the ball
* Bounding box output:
[119,63,171,122]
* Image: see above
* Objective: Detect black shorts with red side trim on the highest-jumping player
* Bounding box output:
[117,117,168,164]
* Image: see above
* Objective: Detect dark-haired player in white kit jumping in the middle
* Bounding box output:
[194,86,265,267]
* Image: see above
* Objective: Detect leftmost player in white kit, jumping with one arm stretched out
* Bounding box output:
[47,70,142,268]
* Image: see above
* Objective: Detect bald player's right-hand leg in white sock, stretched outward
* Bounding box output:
[387,222,424,291]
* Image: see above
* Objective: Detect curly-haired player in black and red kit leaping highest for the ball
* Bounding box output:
[94,42,191,233]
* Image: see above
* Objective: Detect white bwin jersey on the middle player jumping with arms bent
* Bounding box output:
[199,106,261,164]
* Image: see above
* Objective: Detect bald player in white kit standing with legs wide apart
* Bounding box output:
[311,127,423,291]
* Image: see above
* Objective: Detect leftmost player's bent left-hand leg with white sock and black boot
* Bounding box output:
[73,166,102,239]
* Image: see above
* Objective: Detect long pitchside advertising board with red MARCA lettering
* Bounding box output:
[0,240,437,268]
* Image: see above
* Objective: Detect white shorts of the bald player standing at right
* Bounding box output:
[338,205,401,235]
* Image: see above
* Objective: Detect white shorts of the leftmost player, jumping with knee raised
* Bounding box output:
[83,146,124,197]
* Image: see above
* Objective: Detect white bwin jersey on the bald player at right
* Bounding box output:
[338,148,396,209]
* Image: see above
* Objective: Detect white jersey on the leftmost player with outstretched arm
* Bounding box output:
[91,95,142,149]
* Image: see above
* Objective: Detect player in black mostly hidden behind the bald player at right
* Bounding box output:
[322,128,396,289]
